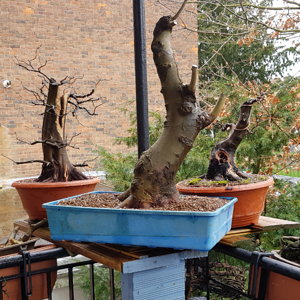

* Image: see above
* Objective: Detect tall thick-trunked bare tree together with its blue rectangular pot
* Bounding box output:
[44,1,236,251]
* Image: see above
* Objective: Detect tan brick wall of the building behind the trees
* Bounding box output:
[0,0,197,178]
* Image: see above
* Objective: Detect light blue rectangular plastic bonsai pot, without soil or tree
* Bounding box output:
[43,192,237,251]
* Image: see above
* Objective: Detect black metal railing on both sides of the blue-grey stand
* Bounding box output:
[0,244,300,300]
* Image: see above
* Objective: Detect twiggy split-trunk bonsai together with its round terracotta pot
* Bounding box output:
[12,54,103,220]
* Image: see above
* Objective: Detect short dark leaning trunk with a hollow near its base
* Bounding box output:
[205,97,261,181]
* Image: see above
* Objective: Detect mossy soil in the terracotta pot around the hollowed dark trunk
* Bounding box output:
[178,174,269,187]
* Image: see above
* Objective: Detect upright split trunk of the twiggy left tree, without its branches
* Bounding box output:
[37,82,87,182]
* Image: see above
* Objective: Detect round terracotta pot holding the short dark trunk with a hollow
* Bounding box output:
[176,177,274,228]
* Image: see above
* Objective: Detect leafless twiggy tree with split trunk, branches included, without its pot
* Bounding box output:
[9,48,103,182]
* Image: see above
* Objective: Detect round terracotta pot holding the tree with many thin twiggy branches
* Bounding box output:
[12,178,100,220]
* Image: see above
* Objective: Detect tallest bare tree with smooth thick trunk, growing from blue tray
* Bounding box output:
[119,0,224,208]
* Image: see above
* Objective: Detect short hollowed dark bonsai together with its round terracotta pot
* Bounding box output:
[177,96,273,228]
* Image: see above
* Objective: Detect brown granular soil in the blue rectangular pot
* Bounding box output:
[58,193,228,212]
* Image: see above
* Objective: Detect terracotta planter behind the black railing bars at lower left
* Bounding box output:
[0,245,57,300]
